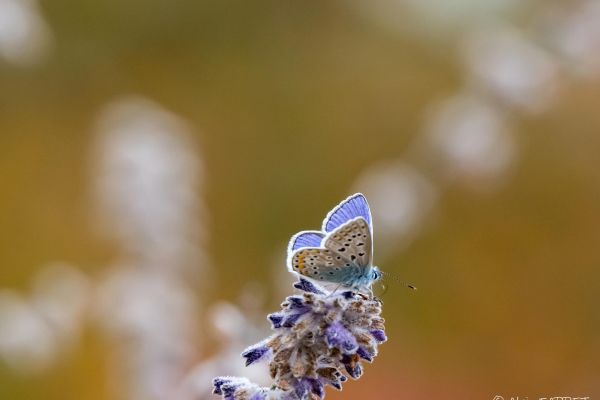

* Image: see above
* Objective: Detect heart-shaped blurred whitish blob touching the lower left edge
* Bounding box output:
[0,264,90,373]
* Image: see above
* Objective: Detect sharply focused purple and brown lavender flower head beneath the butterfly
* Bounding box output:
[213,278,387,400]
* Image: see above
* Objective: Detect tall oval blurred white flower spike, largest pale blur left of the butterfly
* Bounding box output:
[94,97,205,269]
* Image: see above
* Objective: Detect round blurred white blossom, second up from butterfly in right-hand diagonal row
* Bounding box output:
[426,93,516,185]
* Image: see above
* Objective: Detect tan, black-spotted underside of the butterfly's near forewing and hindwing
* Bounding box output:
[289,218,372,286]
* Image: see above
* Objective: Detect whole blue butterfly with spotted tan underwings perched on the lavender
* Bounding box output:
[287,193,382,292]
